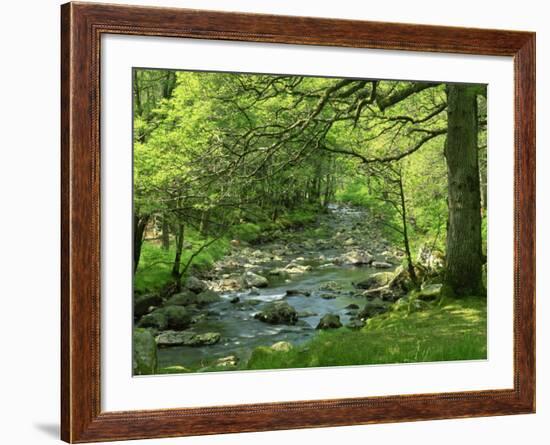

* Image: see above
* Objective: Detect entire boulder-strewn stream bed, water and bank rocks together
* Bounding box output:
[137,205,488,373]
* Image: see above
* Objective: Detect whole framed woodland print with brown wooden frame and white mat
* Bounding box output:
[61,3,535,443]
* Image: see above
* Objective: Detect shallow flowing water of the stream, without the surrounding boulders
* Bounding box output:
[158,206,396,369]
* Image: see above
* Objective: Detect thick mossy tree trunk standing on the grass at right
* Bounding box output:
[443,84,484,296]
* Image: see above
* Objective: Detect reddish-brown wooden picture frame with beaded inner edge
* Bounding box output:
[61,3,535,443]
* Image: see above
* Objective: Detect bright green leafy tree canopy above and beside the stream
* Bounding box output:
[134,69,487,294]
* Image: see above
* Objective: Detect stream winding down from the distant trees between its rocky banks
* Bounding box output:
[158,205,395,369]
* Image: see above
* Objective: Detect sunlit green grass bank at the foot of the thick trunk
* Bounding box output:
[243,297,487,369]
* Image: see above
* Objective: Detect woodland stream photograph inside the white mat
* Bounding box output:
[132,68,487,373]
